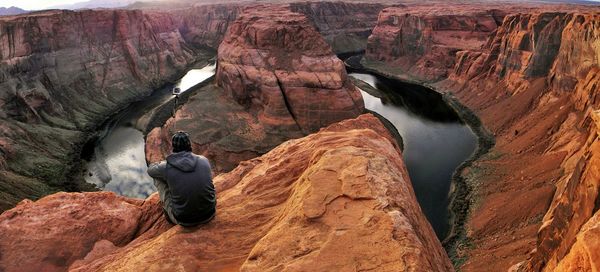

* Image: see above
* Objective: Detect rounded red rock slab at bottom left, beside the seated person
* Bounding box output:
[0,192,162,271]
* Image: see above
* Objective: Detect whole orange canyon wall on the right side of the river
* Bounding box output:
[363,6,600,271]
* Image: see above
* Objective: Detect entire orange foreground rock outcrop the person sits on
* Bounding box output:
[0,115,452,271]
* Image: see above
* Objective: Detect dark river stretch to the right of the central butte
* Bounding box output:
[349,73,476,238]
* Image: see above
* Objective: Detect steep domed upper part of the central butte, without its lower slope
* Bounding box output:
[217,6,364,133]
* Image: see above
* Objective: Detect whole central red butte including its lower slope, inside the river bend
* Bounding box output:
[146,6,364,173]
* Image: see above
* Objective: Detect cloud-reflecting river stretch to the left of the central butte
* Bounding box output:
[84,64,216,198]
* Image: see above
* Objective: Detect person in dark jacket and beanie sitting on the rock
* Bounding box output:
[148,131,216,227]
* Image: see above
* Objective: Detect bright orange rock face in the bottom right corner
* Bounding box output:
[525,109,600,271]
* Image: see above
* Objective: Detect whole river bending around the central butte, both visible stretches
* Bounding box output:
[84,58,477,239]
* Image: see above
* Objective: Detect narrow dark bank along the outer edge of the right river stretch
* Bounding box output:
[352,55,495,267]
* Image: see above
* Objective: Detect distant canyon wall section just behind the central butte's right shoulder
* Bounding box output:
[290,1,385,54]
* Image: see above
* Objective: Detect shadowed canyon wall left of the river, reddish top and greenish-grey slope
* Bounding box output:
[0,10,202,210]
